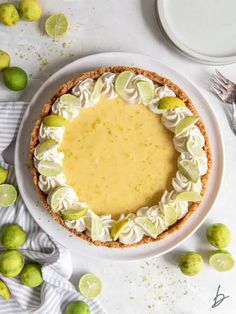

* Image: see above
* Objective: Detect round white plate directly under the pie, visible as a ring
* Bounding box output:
[15,52,224,261]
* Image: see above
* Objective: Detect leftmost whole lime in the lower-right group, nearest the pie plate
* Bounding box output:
[179,252,203,276]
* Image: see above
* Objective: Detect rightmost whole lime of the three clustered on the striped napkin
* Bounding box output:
[20,263,43,288]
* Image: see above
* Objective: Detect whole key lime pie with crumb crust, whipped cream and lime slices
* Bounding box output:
[30,67,212,248]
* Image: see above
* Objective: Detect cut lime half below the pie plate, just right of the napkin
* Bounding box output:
[79,274,102,299]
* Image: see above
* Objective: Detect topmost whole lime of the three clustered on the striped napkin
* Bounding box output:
[0,224,27,250]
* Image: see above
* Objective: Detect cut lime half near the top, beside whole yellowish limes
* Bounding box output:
[45,13,69,38]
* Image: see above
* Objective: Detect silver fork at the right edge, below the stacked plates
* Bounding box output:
[209,70,236,135]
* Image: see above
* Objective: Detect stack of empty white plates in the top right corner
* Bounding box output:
[156,0,236,65]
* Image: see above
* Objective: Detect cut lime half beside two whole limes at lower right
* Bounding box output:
[209,250,235,272]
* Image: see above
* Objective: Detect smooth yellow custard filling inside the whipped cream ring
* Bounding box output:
[60,97,178,217]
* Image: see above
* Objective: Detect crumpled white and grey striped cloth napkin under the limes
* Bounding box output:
[0,102,105,314]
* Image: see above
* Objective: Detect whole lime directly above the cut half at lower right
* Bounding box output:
[206,223,231,249]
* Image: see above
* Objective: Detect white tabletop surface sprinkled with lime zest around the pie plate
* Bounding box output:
[0,0,236,314]
